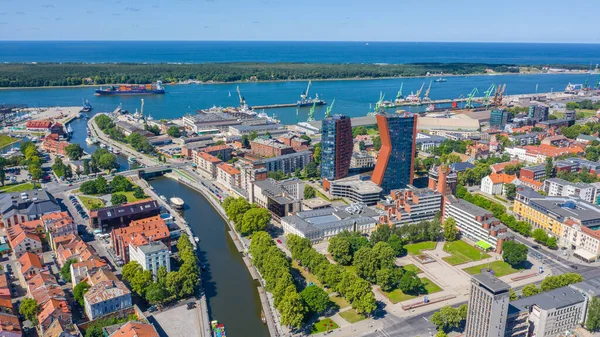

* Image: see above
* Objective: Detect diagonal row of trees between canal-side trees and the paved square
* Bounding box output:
[287,235,377,314]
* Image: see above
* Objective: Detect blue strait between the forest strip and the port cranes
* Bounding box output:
[0,74,597,124]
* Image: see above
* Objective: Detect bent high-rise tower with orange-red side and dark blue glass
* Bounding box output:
[372,112,417,193]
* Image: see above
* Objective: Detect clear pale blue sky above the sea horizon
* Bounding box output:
[0,0,600,43]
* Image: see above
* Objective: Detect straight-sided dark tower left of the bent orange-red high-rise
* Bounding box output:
[321,115,354,181]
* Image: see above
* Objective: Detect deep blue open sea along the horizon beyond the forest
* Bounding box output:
[0,41,600,65]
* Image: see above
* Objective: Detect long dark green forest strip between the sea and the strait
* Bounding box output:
[0,63,552,88]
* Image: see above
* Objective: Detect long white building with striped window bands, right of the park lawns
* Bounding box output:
[442,196,513,254]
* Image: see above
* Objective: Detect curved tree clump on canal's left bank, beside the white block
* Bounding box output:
[122,234,200,304]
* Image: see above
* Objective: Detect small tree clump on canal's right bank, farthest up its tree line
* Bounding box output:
[223,197,271,236]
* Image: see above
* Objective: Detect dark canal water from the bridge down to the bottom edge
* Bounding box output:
[149,177,269,337]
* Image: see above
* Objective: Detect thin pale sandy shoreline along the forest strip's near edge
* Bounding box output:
[0,72,587,90]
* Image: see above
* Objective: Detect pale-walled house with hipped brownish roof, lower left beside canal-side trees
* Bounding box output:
[83,271,132,320]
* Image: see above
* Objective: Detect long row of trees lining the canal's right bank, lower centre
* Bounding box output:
[250,231,304,328]
